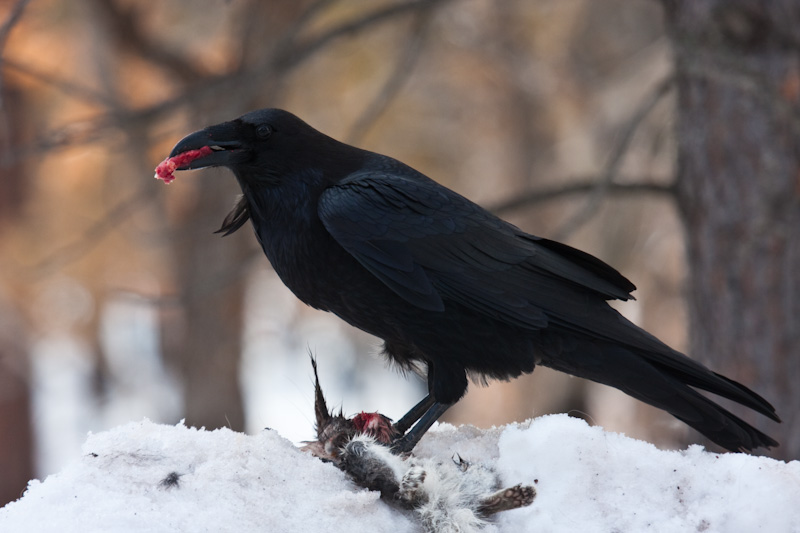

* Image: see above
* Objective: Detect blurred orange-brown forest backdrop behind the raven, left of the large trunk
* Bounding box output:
[0,0,800,508]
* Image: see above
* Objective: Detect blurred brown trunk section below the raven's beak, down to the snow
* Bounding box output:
[164,175,249,431]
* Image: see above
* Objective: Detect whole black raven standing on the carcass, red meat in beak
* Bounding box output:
[159,109,780,451]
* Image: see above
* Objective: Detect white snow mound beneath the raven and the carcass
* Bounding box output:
[0,415,800,533]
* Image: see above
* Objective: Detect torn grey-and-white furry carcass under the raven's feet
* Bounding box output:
[305,359,536,533]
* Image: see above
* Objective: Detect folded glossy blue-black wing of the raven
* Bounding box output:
[318,172,635,329]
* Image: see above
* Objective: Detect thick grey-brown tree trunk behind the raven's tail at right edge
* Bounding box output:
[664,0,800,458]
